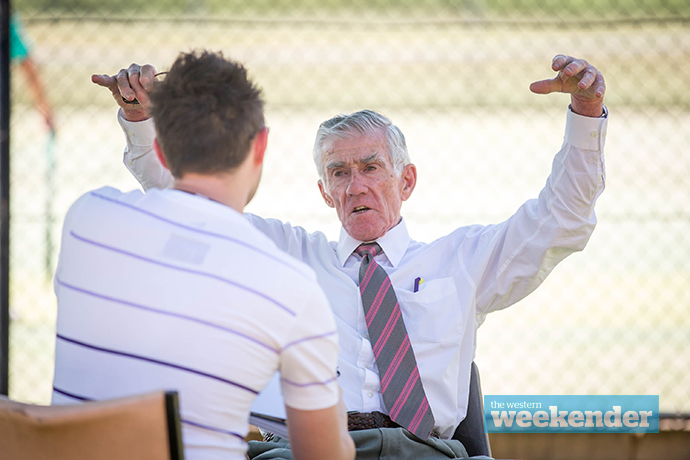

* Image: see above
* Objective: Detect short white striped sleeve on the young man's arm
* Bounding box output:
[280,283,340,410]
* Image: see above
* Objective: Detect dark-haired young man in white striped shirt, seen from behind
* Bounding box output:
[53,52,354,460]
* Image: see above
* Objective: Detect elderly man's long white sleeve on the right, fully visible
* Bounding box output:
[470,110,608,324]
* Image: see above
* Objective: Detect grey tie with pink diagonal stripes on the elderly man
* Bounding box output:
[355,243,434,439]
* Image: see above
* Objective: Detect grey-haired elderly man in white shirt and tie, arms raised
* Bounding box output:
[98,55,607,459]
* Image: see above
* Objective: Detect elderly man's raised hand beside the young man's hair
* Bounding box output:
[91,64,156,121]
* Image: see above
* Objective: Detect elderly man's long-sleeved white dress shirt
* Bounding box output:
[120,110,607,438]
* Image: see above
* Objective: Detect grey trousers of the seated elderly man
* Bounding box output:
[247,428,493,460]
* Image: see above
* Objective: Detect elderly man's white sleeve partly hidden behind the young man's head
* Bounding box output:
[117,109,173,190]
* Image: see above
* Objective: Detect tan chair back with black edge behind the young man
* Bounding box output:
[0,391,184,460]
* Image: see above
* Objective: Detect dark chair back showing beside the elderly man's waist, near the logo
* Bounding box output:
[453,361,491,457]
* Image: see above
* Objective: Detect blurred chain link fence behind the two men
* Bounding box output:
[10,0,690,413]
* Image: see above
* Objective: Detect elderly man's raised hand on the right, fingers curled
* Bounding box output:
[529,54,606,117]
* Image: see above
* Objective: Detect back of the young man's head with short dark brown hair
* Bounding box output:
[151,51,264,178]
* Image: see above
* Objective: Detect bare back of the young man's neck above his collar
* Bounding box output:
[173,173,249,212]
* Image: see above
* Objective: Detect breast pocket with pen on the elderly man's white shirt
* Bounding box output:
[395,278,463,343]
